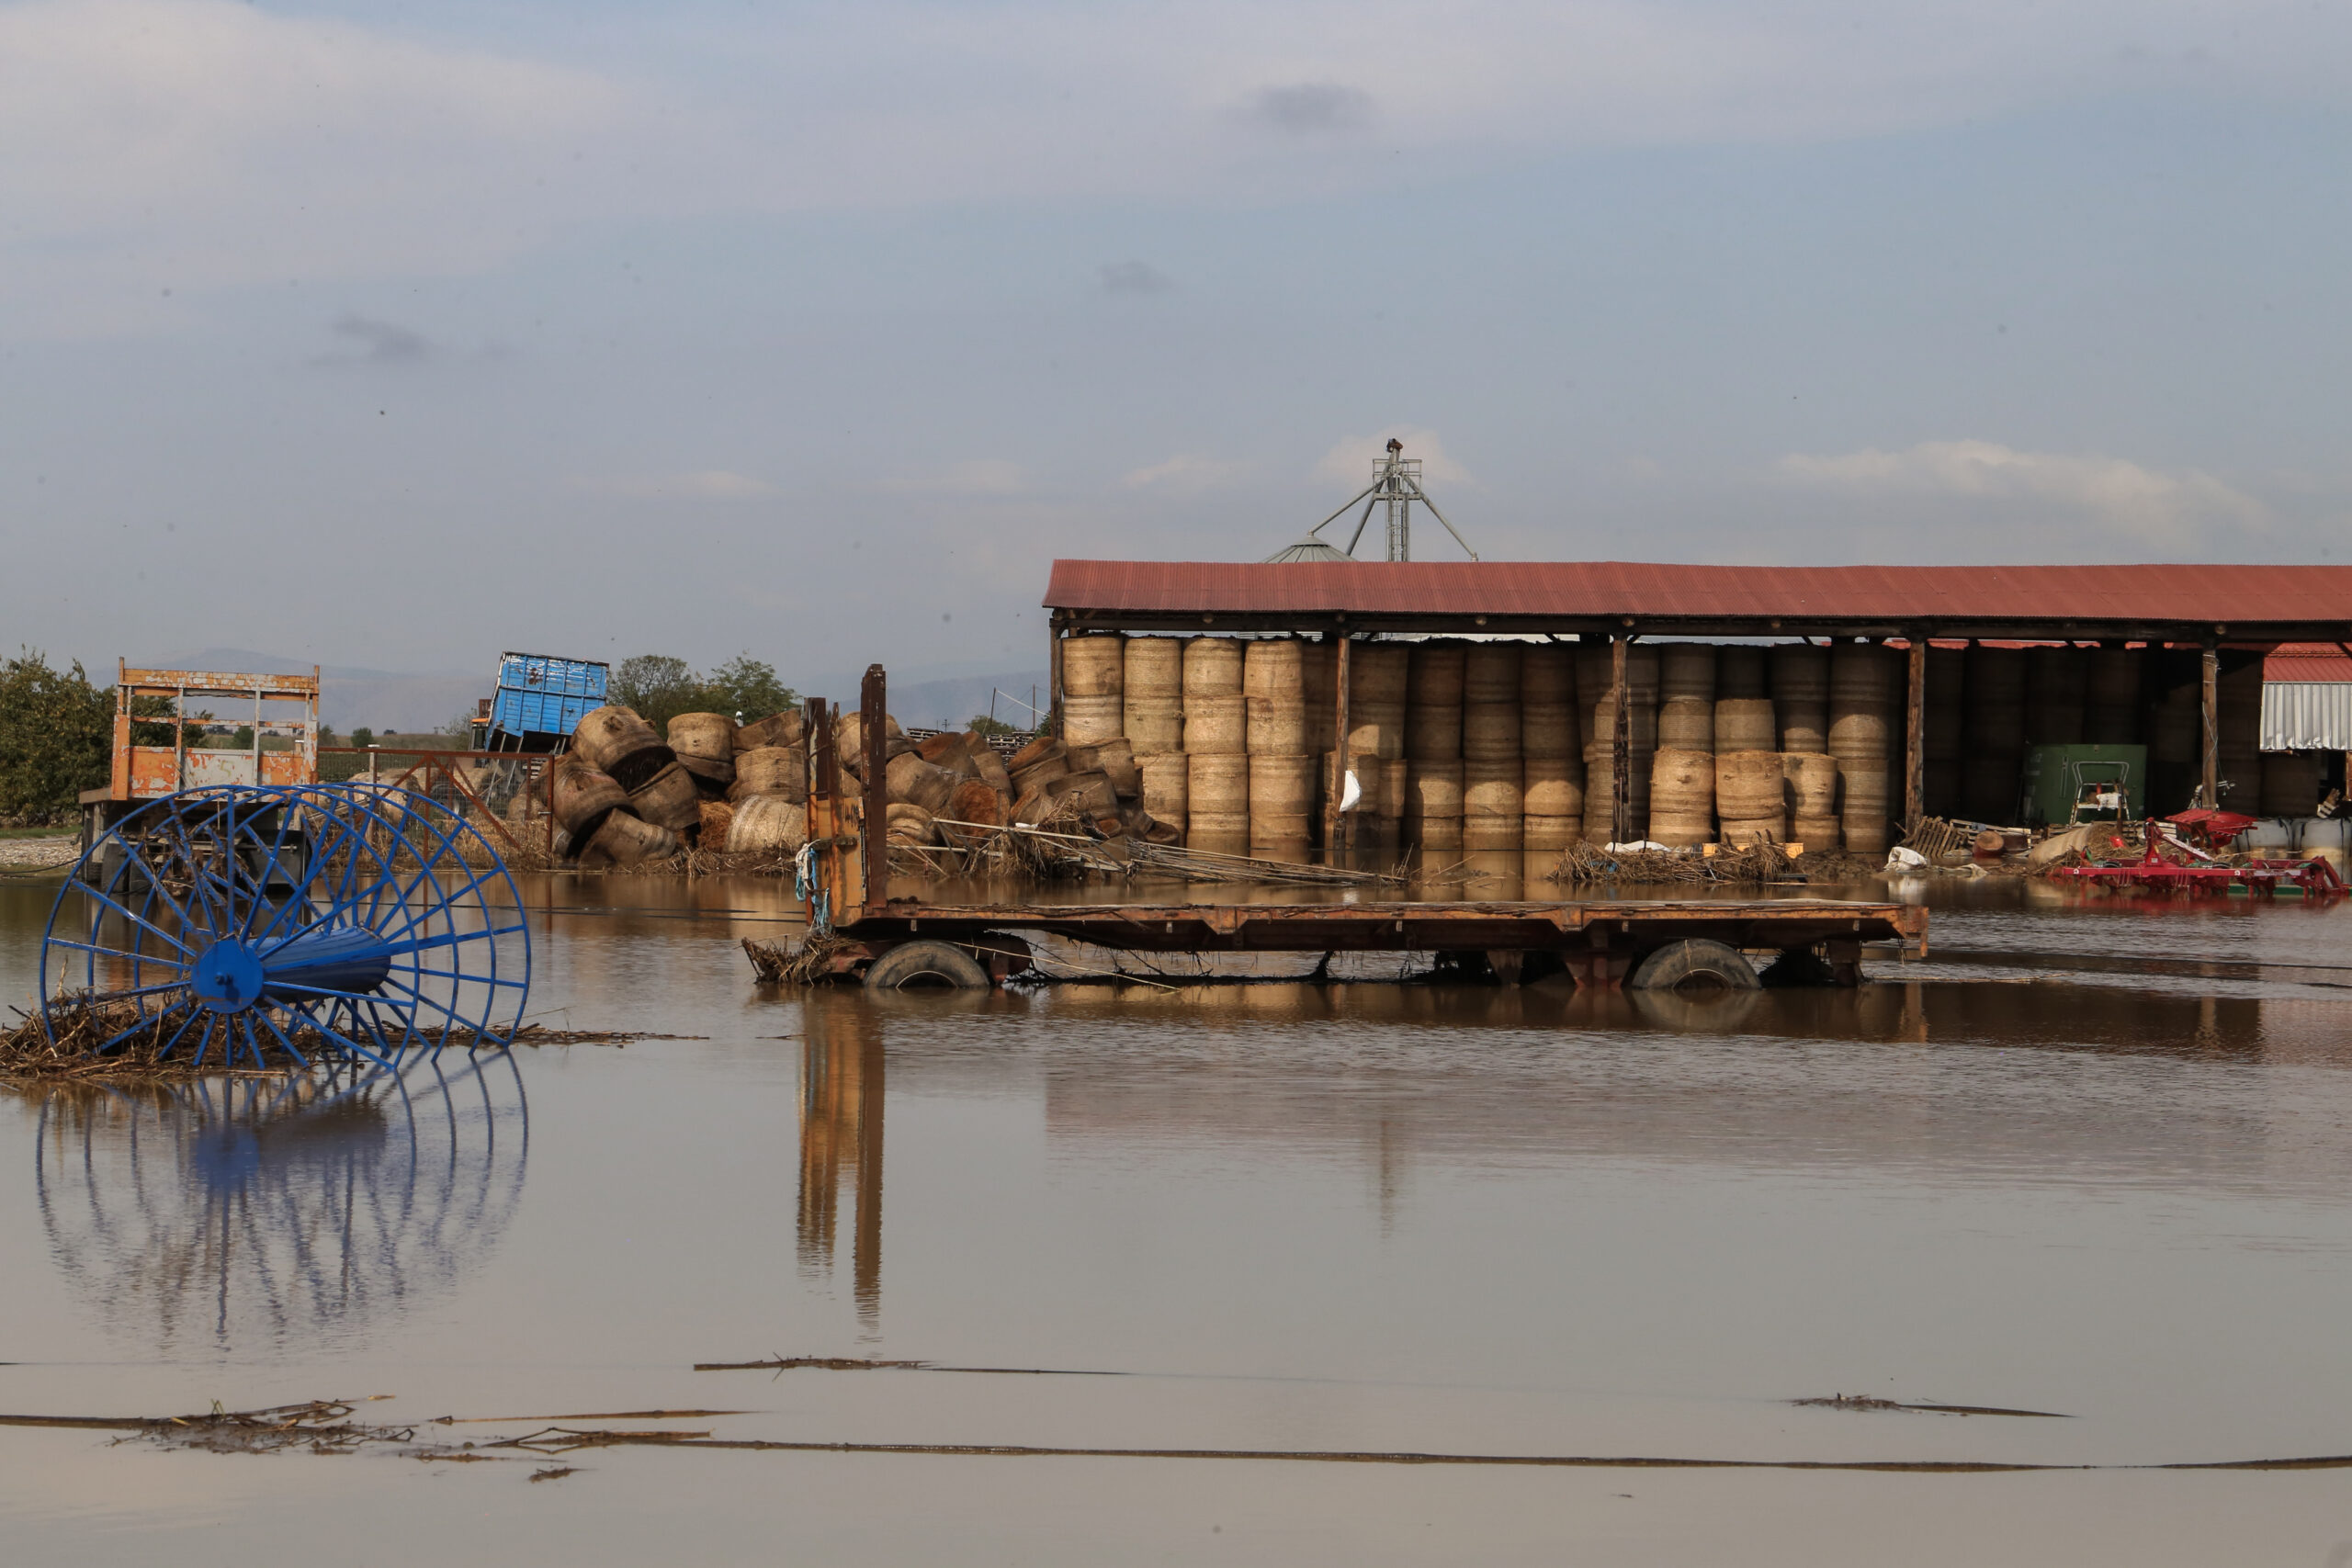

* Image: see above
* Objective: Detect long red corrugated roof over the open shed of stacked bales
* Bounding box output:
[1045,562,2352,632]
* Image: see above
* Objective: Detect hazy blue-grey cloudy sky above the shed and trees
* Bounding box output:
[0,0,2352,684]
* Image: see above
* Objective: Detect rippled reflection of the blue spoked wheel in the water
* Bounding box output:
[33,1051,529,1352]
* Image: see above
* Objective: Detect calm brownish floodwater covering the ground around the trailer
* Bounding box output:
[0,877,2352,1568]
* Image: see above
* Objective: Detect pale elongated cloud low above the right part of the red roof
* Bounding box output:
[1773,442,2269,547]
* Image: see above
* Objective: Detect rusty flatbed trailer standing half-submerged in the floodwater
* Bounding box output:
[802,665,1927,985]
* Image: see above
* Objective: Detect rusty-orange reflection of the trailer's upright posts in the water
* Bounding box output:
[797,989,885,1336]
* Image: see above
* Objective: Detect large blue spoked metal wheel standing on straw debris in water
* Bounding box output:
[40,783,532,1067]
